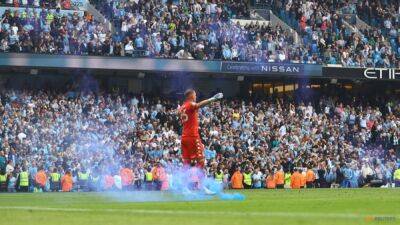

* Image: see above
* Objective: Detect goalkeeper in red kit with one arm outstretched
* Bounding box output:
[179,89,223,168]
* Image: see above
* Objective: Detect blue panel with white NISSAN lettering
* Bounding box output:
[221,62,304,75]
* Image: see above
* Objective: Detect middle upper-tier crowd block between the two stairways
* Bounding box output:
[91,0,310,61]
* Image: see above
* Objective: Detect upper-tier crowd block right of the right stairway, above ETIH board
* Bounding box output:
[269,0,400,68]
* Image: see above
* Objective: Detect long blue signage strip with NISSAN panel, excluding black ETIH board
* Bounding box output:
[0,53,323,77]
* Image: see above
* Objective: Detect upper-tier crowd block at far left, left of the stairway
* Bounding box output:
[0,8,114,55]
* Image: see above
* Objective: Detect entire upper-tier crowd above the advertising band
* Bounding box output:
[0,0,400,67]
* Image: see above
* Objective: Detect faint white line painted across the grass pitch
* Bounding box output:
[0,206,399,219]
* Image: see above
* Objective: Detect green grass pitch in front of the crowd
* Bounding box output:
[0,189,400,225]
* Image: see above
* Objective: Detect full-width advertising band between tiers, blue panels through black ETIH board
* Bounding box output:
[0,53,400,81]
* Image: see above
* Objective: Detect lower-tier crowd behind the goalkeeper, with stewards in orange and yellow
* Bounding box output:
[0,87,400,192]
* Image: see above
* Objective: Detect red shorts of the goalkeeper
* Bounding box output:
[181,137,204,163]
